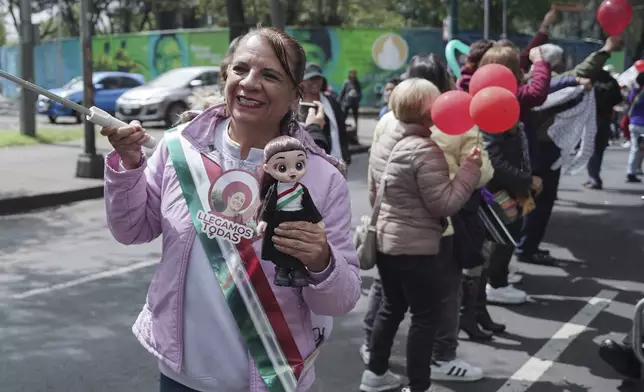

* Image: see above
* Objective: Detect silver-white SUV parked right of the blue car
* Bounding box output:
[116,66,219,127]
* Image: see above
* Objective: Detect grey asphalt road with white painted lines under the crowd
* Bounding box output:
[0,145,644,392]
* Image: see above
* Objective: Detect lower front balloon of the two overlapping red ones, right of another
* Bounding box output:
[470,86,521,133]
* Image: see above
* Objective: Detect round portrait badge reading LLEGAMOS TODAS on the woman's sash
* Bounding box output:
[197,170,260,244]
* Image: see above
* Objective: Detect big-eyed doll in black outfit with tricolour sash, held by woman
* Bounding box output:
[257,136,322,287]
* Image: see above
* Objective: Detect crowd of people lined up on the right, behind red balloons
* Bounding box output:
[359,10,644,392]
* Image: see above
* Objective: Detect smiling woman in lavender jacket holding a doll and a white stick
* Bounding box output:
[101,28,360,392]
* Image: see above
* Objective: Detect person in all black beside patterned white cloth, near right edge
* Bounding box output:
[584,70,624,189]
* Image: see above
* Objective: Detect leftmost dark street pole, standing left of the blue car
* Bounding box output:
[20,0,36,137]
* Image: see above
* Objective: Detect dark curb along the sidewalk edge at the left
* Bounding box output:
[0,185,104,216]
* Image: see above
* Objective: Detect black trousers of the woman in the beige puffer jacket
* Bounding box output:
[368,253,447,392]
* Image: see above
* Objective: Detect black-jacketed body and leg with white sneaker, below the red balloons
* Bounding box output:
[483,123,541,305]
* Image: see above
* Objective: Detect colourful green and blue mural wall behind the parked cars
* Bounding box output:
[0,27,599,106]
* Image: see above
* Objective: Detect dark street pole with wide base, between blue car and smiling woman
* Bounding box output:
[76,0,104,178]
